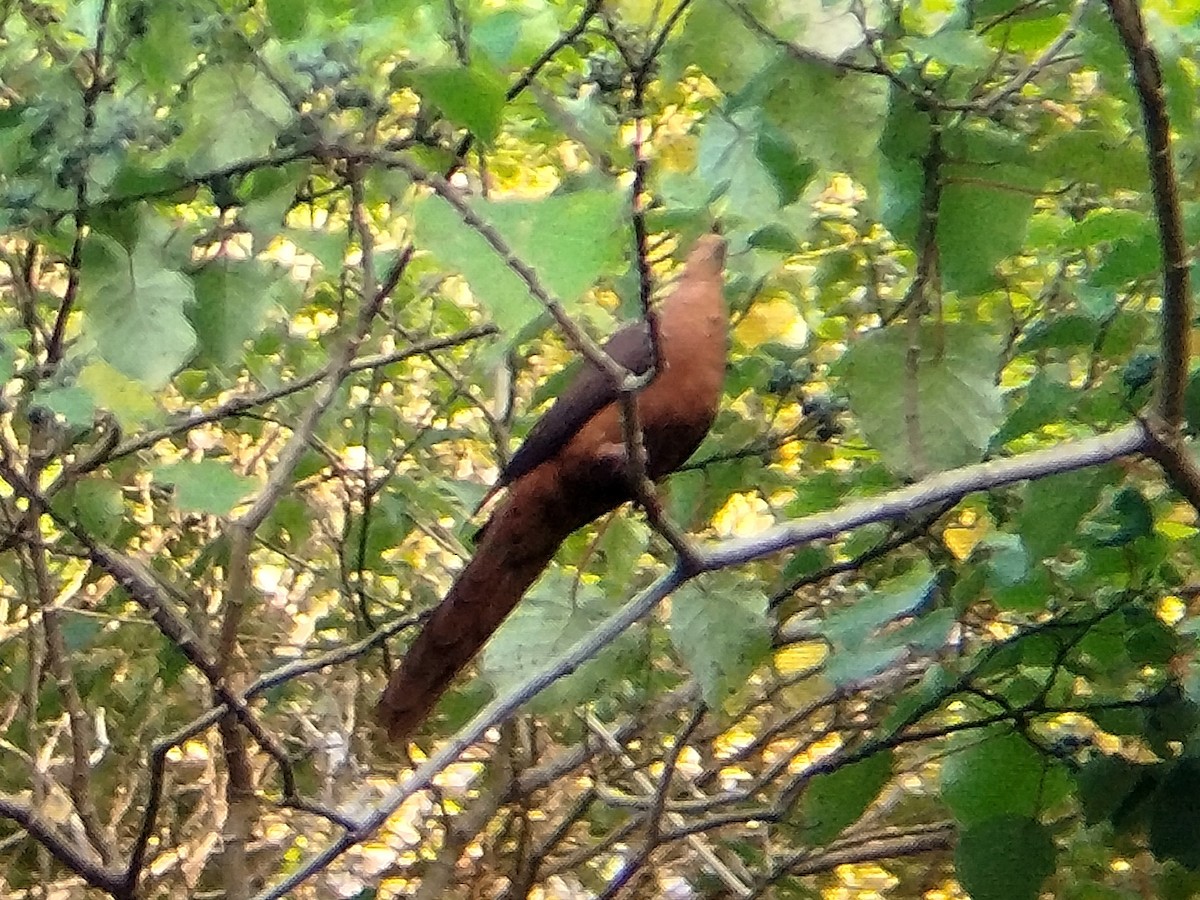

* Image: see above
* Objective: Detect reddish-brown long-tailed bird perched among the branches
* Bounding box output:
[378,234,728,740]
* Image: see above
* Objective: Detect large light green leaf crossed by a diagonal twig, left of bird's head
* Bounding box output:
[415,191,628,334]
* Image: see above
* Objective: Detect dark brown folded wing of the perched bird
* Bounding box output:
[499,322,654,485]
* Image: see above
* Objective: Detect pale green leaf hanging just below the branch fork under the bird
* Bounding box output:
[671,574,770,709]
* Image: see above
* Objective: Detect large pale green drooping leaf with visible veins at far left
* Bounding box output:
[79,234,196,389]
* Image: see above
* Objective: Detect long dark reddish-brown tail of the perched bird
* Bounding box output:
[378,466,624,740]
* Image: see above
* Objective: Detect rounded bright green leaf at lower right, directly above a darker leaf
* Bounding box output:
[941,730,1048,826]
